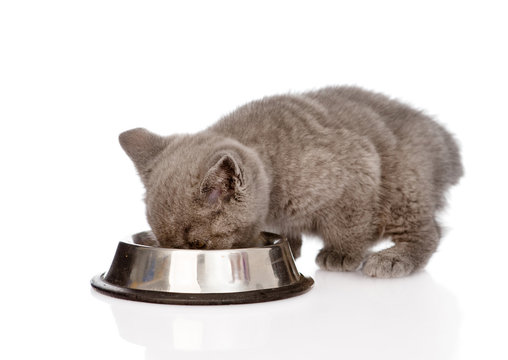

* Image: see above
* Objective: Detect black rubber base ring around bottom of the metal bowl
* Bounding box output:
[91,274,314,305]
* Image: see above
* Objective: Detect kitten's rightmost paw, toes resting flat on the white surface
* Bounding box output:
[362,251,415,278]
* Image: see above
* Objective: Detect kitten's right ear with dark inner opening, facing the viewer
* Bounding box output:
[201,155,243,204]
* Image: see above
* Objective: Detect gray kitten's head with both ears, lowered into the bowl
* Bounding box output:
[120,129,268,249]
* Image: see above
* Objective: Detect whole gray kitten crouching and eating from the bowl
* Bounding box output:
[120,87,463,278]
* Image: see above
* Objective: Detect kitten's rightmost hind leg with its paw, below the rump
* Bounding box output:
[362,220,440,278]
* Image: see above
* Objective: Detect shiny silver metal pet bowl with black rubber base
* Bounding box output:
[91,232,314,305]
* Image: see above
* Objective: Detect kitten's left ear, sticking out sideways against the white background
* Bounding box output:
[118,128,168,180]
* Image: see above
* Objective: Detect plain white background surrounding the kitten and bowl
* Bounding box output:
[0,0,508,359]
